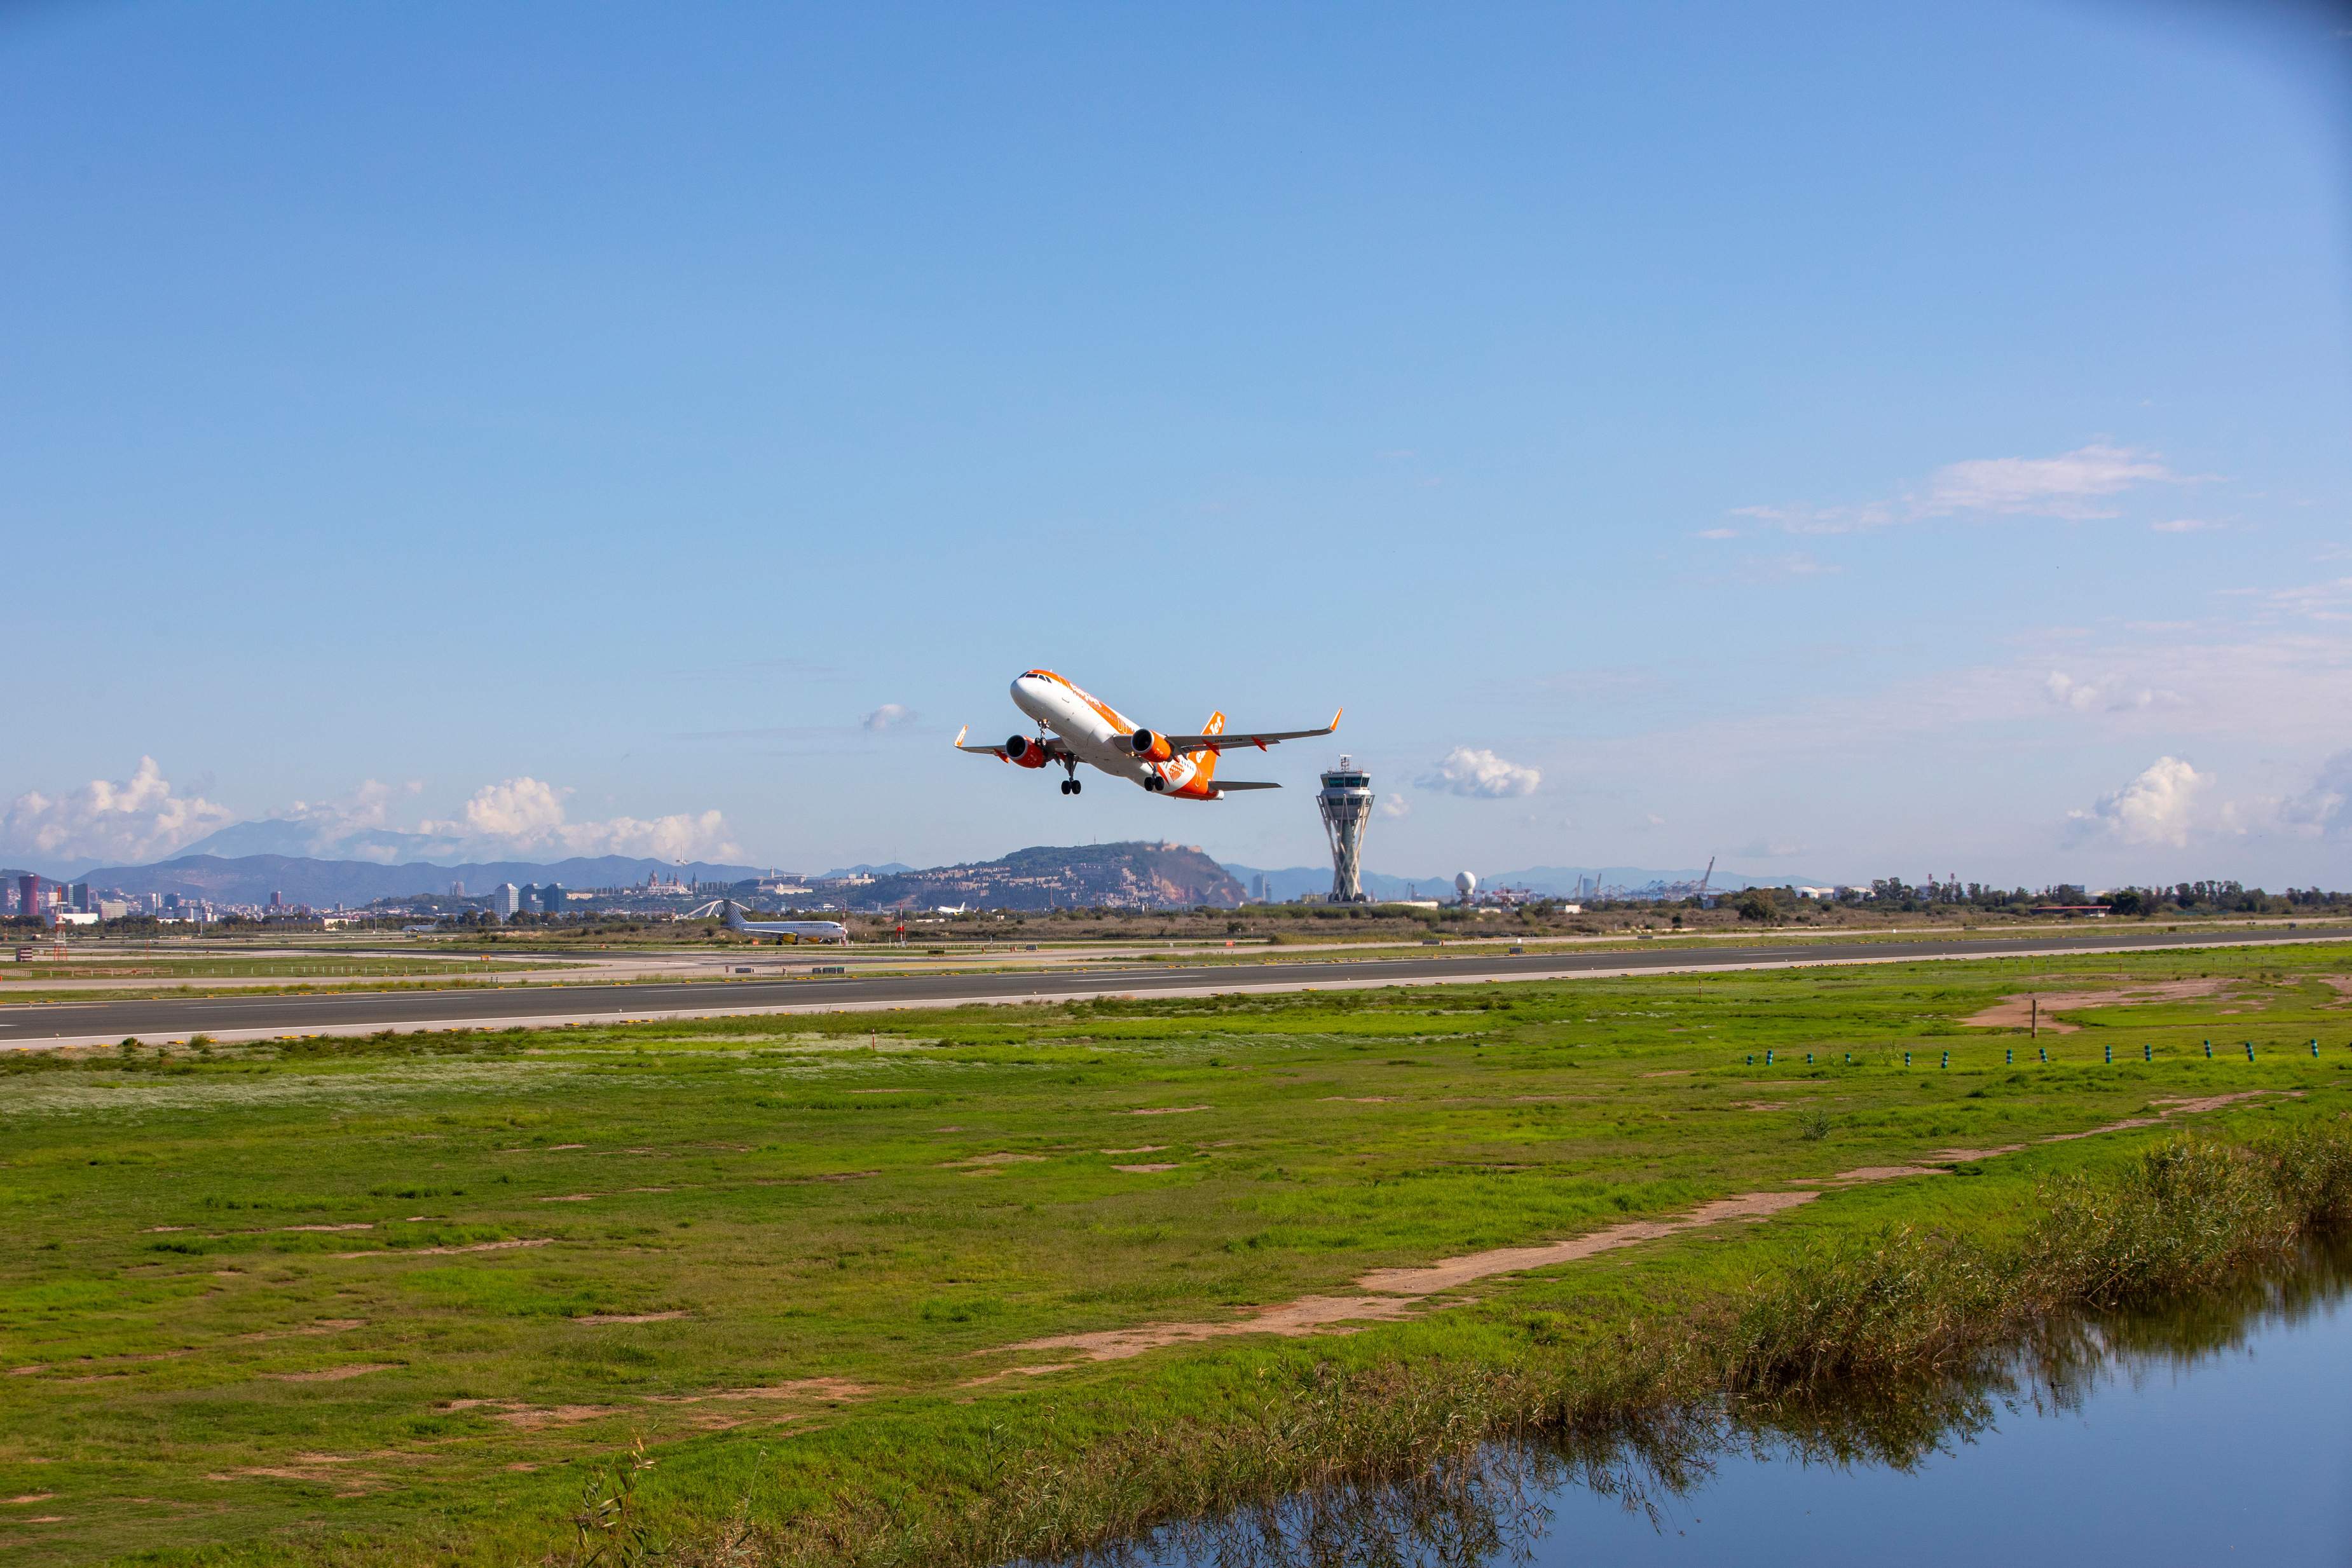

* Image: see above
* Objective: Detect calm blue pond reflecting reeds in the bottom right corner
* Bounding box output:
[1119,1248,2352,1568]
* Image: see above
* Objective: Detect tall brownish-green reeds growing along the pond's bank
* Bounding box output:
[644,1124,2352,1568]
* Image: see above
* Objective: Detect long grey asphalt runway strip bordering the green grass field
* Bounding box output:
[0,929,2348,1046]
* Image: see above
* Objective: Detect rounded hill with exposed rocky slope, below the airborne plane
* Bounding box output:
[851,842,1242,910]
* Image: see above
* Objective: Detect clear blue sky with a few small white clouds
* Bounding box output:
[0,0,2352,886]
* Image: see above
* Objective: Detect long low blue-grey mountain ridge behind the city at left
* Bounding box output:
[75,856,760,908]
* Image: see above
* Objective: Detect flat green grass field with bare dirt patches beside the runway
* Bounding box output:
[0,945,2352,1564]
